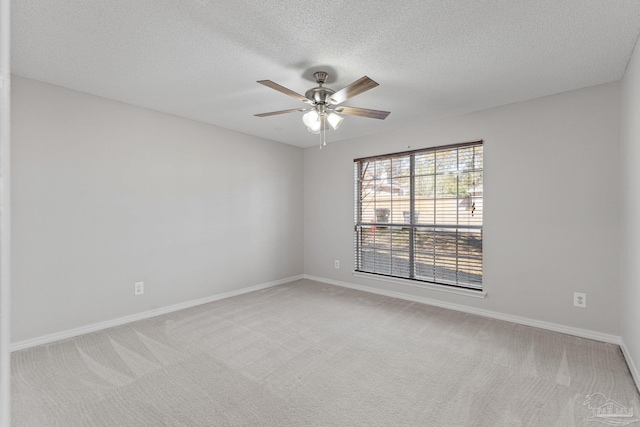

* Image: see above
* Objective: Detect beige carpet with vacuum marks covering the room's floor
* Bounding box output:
[12,280,640,427]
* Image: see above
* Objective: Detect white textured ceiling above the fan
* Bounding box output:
[11,0,640,147]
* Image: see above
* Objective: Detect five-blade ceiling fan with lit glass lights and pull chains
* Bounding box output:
[255,71,390,145]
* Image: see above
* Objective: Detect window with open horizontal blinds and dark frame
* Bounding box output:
[354,141,483,290]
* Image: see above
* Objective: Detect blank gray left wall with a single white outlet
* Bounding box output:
[11,77,304,342]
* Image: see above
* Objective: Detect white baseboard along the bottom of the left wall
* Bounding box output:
[11,274,304,351]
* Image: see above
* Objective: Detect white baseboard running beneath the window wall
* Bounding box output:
[304,274,622,345]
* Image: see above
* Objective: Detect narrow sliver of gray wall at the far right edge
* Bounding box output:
[620,38,640,386]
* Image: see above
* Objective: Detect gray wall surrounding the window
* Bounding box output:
[304,83,620,335]
